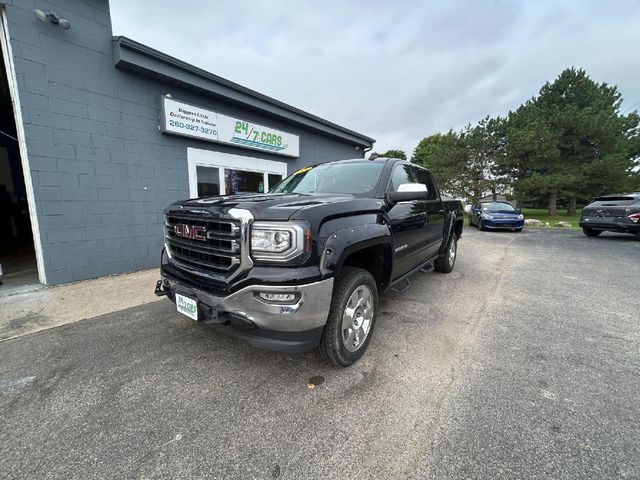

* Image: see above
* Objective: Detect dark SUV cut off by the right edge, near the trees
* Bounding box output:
[580,192,640,240]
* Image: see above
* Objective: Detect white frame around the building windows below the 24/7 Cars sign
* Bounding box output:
[187,147,287,198]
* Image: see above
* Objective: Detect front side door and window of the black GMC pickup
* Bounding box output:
[387,164,427,278]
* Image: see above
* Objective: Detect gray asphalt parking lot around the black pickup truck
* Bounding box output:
[0,228,640,479]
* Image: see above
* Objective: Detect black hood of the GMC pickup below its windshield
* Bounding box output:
[167,193,382,221]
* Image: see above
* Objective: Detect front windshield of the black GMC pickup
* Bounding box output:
[269,161,383,195]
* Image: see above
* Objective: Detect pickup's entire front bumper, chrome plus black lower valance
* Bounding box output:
[158,274,333,352]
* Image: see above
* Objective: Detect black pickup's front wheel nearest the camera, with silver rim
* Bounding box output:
[317,267,378,367]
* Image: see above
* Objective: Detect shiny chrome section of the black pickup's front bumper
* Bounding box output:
[163,276,333,332]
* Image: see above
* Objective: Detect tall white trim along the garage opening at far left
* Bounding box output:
[0,5,47,285]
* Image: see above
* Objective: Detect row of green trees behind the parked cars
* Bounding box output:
[374,68,640,215]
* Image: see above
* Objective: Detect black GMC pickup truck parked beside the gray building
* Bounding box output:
[156,158,463,366]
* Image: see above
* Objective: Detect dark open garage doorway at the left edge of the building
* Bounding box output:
[0,10,39,295]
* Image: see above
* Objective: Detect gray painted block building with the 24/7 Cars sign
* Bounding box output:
[0,0,374,288]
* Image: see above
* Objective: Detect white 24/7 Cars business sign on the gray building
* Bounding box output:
[160,97,300,157]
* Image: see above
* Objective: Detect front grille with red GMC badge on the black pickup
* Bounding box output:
[164,214,242,277]
